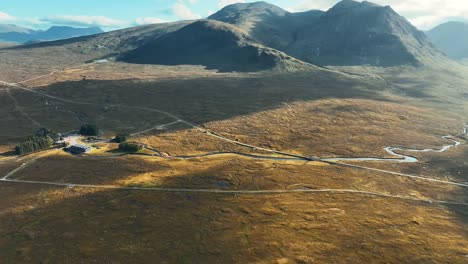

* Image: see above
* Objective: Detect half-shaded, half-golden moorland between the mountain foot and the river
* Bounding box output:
[1,64,461,160]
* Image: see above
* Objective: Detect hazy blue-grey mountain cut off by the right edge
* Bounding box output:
[426,22,468,60]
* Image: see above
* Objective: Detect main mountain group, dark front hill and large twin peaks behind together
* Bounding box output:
[8,0,460,71]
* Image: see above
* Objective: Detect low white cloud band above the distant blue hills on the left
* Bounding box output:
[39,15,128,28]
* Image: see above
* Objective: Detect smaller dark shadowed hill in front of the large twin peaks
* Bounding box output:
[120,20,307,71]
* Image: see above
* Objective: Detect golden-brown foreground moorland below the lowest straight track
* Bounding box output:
[0,179,468,263]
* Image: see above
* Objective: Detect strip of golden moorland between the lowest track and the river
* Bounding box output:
[9,151,465,202]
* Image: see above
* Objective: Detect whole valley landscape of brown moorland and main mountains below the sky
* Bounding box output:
[0,0,468,263]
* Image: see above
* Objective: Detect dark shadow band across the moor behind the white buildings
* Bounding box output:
[3,72,389,141]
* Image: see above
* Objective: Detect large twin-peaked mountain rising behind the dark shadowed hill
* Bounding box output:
[209,0,439,66]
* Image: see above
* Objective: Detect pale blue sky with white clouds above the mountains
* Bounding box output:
[0,0,468,30]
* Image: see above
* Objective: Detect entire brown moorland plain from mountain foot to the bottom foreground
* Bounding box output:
[0,61,468,263]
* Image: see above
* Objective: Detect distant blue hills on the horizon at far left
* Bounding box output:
[0,25,104,43]
